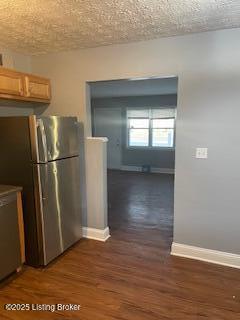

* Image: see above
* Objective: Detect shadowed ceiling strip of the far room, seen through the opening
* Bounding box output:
[90,77,177,98]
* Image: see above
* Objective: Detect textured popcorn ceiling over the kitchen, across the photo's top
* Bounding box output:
[0,0,240,54]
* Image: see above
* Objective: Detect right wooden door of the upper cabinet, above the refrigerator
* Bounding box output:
[25,75,51,101]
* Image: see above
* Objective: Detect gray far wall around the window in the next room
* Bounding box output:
[91,94,177,169]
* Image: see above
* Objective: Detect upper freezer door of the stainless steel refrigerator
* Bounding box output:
[30,116,79,163]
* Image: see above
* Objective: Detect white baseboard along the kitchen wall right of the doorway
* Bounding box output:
[171,242,240,269]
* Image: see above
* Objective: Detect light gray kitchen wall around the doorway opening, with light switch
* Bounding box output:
[32,29,240,254]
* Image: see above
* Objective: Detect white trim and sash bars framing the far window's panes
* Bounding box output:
[126,113,176,151]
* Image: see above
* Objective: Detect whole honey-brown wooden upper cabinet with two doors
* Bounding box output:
[0,67,51,103]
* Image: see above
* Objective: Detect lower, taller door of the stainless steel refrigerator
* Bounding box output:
[36,157,82,265]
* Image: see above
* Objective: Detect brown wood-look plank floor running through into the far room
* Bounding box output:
[0,171,240,320]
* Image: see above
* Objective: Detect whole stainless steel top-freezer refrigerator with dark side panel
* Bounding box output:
[0,116,82,266]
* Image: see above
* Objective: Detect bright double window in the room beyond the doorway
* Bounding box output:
[127,108,175,148]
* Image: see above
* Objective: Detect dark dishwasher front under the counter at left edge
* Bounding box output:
[0,193,21,280]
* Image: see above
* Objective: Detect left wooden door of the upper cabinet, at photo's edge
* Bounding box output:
[0,68,24,96]
